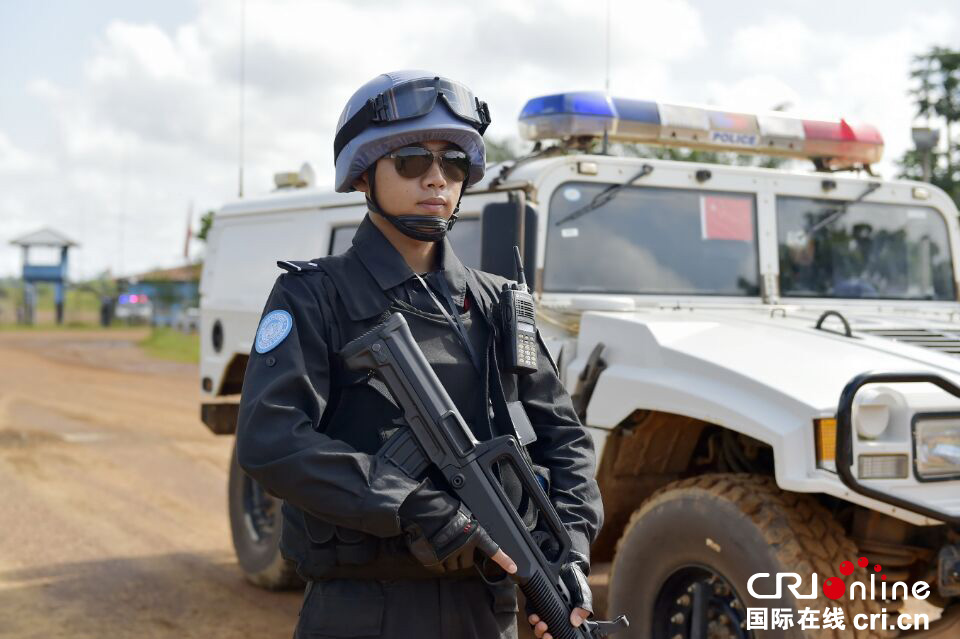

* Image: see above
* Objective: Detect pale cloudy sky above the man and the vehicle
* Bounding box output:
[0,0,960,280]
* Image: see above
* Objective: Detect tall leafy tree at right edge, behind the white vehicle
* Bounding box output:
[897,47,960,206]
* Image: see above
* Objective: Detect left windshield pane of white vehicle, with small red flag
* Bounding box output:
[543,182,760,296]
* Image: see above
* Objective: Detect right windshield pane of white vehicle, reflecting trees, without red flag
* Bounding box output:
[777,197,956,300]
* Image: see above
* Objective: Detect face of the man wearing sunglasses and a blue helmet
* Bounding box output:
[354,140,463,218]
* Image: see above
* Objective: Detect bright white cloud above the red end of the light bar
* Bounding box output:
[710,13,960,176]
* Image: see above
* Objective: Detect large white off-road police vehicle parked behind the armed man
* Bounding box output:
[201,92,960,639]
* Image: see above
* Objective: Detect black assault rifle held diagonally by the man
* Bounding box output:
[340,313,629,639]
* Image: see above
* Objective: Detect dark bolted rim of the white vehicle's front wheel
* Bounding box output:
[653,566,753,639]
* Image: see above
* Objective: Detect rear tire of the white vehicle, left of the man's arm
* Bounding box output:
[227,443,304,590]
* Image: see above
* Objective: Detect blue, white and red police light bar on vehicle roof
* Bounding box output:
[520,91,883,168]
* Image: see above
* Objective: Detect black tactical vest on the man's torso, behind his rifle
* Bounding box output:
[280,252,545,580]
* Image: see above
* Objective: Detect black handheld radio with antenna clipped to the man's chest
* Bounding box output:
[500,246,537,375]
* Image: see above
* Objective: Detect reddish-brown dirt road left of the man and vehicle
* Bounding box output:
[0,330,300,639]
